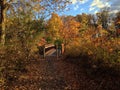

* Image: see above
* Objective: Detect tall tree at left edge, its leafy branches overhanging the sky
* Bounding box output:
[0,0,69,45]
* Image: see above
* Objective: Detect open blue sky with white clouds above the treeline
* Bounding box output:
[61,0,120,16]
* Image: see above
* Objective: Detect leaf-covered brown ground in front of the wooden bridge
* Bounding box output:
[0,57,120,90]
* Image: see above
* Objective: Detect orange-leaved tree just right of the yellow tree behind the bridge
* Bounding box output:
[60,18,80,45]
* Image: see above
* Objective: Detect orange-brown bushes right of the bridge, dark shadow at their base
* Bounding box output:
[66,36,120,74]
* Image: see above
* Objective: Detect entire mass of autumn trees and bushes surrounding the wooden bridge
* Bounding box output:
[0,0,120,90]
